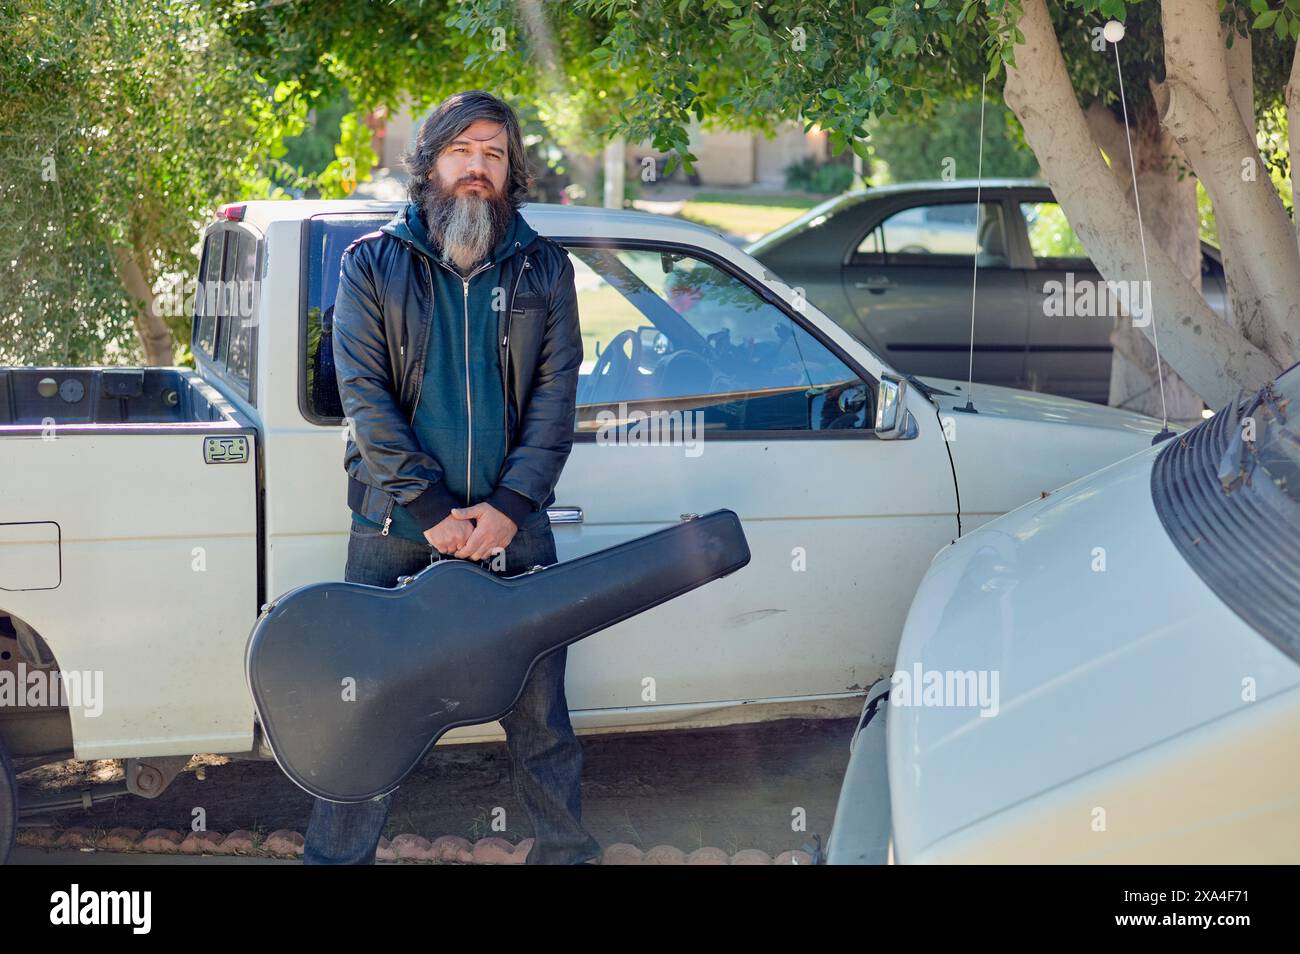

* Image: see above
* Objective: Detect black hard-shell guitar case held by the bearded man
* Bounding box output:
[244,509,749,802]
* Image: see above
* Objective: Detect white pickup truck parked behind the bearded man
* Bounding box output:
[0,201,1158,853]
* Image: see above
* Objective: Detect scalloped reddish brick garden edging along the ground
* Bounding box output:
[17,828,813,866]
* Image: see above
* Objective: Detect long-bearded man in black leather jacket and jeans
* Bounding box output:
[303,90,601,864]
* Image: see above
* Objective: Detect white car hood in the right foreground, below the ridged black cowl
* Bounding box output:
[888,444,1300,862]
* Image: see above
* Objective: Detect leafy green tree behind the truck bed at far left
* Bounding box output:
[0,0,369,364]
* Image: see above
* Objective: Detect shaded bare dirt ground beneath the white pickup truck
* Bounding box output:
[21,719,855,857]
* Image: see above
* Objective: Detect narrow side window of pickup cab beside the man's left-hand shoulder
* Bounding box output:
[302,213,393,424]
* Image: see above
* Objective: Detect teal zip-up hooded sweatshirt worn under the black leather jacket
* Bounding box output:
[352,203,537,543]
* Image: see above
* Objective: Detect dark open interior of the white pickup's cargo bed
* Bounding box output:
[0,368,235,428]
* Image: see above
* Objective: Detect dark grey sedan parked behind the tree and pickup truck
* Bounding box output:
[746,179,1226,403]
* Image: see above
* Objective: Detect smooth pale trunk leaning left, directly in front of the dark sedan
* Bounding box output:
[1005,0,1279,407]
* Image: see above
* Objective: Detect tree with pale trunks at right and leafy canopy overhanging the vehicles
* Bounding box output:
[271,0,1279,419]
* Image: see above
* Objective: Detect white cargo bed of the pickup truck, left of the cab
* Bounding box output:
[0,368,263,759]
